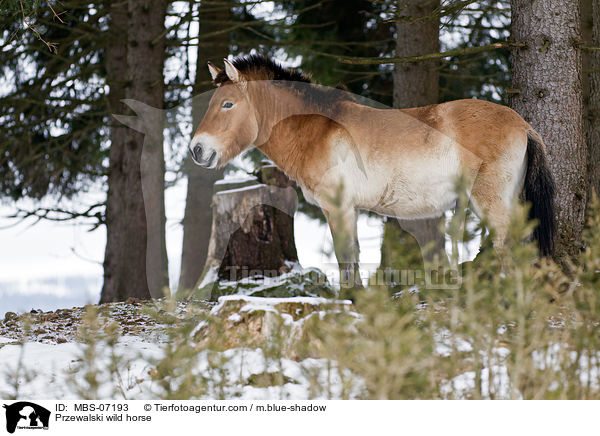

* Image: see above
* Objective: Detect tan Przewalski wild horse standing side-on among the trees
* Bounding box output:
[189,56,555,286]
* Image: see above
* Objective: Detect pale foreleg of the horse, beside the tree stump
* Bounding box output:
[325,207,362,289]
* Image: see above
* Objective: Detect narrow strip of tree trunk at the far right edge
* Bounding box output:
[582,0,600,198]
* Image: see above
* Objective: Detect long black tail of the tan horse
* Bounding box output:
[525,131,556,256]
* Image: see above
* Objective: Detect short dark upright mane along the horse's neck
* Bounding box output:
[214,55,354,110]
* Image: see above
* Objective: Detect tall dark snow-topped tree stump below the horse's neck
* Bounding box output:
[202,165,298,290]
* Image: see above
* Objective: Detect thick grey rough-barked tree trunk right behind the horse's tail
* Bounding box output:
[511,0,587,259]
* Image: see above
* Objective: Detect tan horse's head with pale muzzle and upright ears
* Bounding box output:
[189,60,258,168]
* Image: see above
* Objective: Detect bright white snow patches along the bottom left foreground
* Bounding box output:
[0,336,360,400]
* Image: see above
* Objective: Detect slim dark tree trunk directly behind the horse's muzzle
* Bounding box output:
[179,0,231,289]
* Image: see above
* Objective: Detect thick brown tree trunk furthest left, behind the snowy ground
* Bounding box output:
[100,0,168,302]
